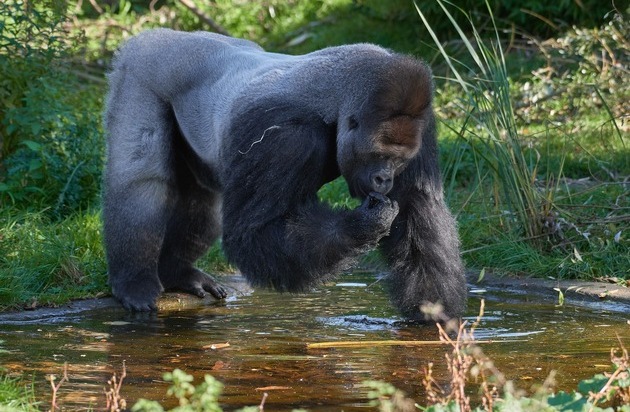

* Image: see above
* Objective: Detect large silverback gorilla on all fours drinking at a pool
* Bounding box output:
[104,29,466,320]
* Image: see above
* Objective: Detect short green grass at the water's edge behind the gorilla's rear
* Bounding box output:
[0,210,107,310]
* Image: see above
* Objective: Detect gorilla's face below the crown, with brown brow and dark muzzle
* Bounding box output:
[337,115,423,198]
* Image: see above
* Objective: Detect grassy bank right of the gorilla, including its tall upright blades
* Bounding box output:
[428,1,630,280]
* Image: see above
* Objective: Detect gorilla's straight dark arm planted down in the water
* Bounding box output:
[383,116,467,321]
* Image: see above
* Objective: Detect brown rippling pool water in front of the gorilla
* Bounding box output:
[0,275,630,411]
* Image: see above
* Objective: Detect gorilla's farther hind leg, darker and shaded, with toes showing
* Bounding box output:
[158,182,227,299]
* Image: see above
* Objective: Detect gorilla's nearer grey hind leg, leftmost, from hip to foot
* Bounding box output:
[103,74,177,311]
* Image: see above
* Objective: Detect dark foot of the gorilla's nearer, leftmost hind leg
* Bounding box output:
[112,278,163,312]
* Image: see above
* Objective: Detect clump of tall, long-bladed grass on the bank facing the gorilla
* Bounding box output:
[416,0,562,240]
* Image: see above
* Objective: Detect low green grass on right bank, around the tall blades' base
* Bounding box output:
[455,185,630,280]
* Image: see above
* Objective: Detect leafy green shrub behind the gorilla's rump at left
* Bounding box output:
[0,0,102,215]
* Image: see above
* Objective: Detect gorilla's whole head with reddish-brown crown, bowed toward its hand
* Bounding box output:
[337,55,433,198]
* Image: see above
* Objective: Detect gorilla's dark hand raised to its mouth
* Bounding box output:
[351,192,398,247]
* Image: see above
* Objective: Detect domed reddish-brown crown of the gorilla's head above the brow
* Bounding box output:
[370,55,433,118]
